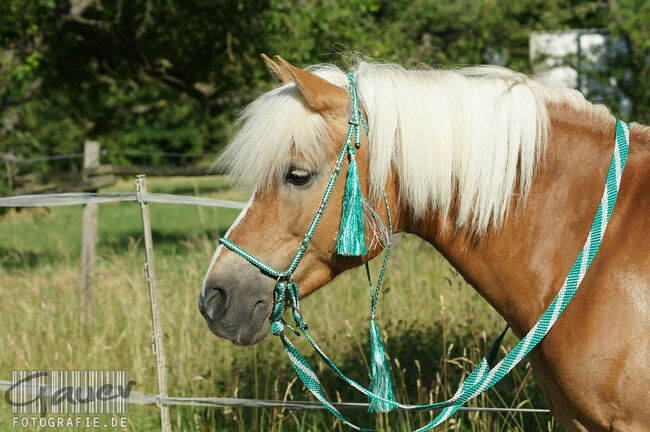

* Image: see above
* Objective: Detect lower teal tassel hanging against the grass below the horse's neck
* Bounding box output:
[368,319,397,412]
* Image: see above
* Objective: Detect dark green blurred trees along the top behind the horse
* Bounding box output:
[0,0,650,179]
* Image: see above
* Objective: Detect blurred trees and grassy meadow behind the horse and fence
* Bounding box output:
[0,0,650,432]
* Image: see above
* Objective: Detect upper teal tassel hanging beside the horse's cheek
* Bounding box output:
[335,146,368,256]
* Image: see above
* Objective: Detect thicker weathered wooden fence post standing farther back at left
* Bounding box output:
[81,141,100,328]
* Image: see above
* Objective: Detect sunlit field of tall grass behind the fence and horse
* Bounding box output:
[0,178,561,432]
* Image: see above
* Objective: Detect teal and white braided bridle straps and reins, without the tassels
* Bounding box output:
[219,74,629,432]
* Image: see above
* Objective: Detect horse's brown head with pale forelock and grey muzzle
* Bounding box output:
[199,56,392,345]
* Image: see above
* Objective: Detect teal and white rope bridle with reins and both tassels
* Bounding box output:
[214,74,629,432]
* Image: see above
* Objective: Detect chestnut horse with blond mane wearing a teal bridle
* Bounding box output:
[200,56,650,431]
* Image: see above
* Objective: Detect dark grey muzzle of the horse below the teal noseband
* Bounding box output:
[199,277,273,345]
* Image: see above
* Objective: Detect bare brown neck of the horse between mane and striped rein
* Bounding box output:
[404,105,615,336]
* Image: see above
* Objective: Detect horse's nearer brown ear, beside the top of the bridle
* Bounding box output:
[275,55,350,113]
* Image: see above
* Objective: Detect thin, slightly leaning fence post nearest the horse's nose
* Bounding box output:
[135,175,172,432]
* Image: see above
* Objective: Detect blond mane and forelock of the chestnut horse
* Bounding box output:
[218,61,611,234]
